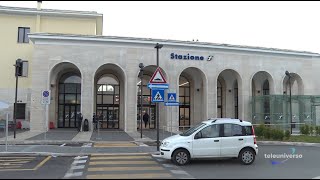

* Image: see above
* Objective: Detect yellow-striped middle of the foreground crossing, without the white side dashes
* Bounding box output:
[86,153,174,179]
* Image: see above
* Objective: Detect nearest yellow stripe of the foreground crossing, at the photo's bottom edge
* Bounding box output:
[87,173,172,179]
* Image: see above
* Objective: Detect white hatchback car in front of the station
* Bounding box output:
[160,118,258,165]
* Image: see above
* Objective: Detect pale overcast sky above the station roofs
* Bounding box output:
[0,1,320,53]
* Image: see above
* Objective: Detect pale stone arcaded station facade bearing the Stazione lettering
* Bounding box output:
[29,33,320,132]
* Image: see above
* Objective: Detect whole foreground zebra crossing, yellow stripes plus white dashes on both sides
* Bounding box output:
[64,153,194,179]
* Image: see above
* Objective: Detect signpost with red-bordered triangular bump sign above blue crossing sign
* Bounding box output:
[148,65,169,151]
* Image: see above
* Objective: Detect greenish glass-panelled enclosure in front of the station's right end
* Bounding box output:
[250,95,320,131]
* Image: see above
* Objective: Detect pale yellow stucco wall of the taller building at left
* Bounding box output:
[0,9,103,120]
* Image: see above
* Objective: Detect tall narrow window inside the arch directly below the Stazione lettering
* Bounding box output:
[179,76,190,127]
